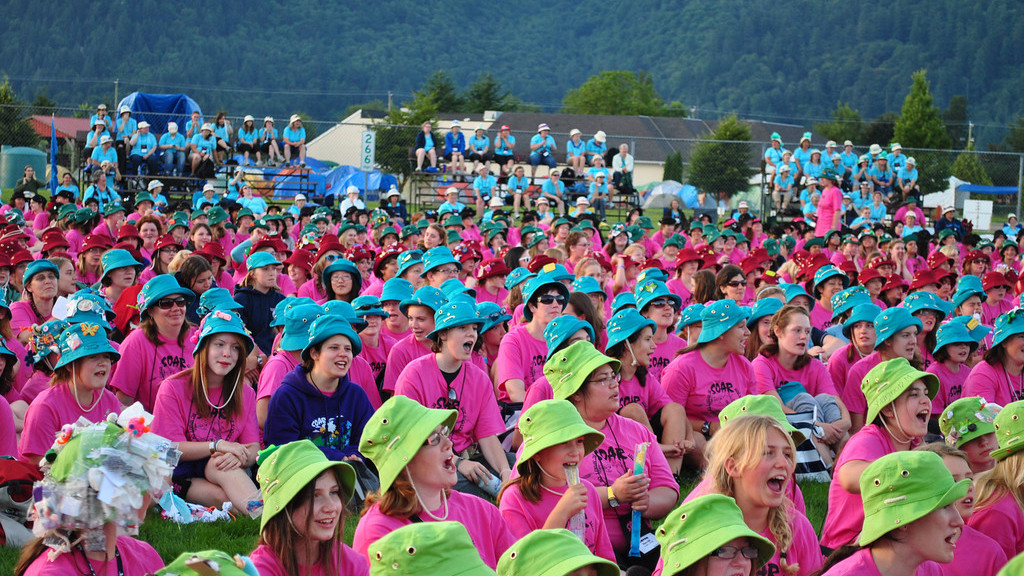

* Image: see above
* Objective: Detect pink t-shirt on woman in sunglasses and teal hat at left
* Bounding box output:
[110,328,196,412]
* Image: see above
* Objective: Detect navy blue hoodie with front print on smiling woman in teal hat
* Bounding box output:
[263,365,374,460]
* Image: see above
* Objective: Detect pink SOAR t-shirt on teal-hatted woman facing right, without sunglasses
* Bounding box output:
[662,349,756,422]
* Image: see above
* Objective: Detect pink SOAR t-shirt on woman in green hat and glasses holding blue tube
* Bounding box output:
[580,414,679,551]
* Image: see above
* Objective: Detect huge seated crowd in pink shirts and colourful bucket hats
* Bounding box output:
[0,129,1024,576]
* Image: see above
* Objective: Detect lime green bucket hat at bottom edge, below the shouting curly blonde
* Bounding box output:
[654,494,775,574]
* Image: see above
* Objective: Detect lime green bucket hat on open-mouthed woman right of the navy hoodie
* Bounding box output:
[359,396,459,494]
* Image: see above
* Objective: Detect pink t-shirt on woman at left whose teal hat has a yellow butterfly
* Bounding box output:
[17,383,121,464]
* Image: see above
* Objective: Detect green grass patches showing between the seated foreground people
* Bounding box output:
[0,481,828,574]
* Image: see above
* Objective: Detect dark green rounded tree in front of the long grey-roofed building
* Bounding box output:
[687,115,756,196]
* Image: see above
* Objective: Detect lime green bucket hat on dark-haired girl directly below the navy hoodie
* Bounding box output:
[256,440,355,532]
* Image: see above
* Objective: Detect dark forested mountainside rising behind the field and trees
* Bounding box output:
[0,0,1024,139]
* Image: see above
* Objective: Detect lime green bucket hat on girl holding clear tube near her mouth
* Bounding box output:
[515,400,604,474]
